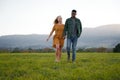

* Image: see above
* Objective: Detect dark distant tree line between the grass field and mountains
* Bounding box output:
[0,43,120,53]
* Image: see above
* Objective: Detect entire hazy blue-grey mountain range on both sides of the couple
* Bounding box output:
[0,24,120,49]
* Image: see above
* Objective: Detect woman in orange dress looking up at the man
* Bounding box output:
[47,16,64,62]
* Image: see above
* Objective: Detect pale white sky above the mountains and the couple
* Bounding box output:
[0,0,120,36]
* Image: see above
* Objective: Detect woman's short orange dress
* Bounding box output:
[53,24,64,48]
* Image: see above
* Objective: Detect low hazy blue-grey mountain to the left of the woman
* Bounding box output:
[0,34,52,48]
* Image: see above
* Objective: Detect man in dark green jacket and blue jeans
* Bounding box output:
[63,10,82,62]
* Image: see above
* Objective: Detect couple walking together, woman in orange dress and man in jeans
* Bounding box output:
[47,10,82,62]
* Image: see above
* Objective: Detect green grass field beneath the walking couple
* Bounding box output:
[0,53,120,80]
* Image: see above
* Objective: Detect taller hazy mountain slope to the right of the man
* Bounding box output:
[78,24,120,48]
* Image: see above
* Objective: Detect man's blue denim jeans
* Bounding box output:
[67,36,78,61]
